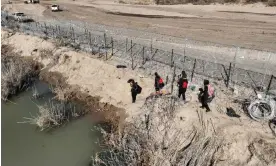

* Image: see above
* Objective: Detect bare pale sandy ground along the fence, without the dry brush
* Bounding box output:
[1,30,276,166]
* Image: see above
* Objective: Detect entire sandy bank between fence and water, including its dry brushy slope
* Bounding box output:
[2,31,276,166]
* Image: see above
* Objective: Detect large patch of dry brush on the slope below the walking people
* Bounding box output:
[92,96,222,166]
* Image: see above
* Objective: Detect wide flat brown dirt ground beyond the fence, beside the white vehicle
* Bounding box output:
[44,0,276,50]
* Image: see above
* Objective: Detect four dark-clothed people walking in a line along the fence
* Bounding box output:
[128,71,215,112]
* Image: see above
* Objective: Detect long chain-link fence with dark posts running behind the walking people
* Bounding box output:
[1,12,276,92]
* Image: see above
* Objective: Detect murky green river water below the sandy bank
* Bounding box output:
[1,82,101,166]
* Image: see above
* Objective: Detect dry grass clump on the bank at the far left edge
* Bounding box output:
[1,45,41,101]
